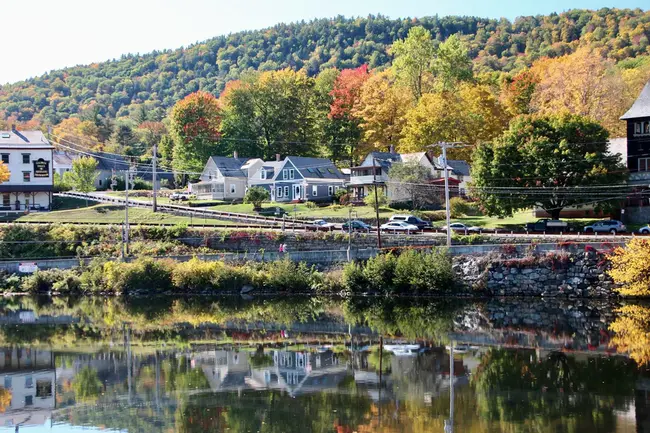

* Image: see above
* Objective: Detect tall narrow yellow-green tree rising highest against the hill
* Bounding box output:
[392,26,435,100]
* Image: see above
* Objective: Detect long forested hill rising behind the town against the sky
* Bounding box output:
[0,9,650,124]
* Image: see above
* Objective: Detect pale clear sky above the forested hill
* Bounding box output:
[0,0,648,83]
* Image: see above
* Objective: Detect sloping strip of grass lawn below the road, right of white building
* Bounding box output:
[15,200,234,226]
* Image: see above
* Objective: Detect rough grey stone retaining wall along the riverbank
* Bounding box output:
[454,251,616,298]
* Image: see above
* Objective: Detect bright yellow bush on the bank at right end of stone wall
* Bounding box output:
[608,238,650,296]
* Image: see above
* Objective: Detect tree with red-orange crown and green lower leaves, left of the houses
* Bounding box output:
[170,92,221,173]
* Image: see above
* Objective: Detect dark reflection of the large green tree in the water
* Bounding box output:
[472,348,636,432]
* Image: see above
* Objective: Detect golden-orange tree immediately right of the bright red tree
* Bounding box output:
[352,70,413,153]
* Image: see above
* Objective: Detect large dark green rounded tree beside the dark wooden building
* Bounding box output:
[472,114,627,219]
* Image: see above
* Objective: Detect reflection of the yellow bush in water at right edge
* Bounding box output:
[610,304,650,365]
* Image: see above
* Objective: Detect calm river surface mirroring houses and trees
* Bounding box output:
[0,298,650,433]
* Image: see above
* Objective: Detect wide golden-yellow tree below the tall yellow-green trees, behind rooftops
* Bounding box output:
[399,83,509,160]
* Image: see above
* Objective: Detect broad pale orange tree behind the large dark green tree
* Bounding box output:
[531,48,629,137]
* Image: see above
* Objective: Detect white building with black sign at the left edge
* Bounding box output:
[0,127,54,211]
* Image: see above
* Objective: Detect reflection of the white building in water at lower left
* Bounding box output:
[0,348,56,426]
